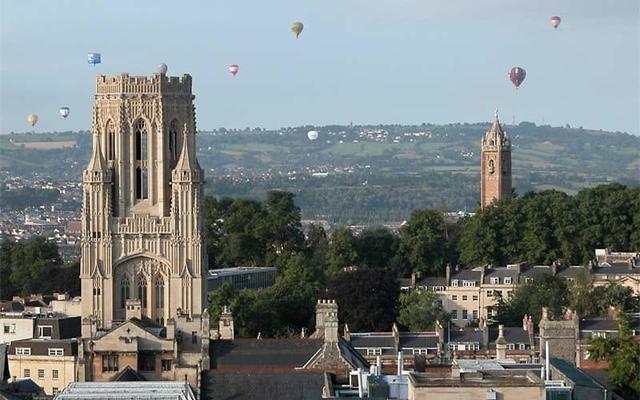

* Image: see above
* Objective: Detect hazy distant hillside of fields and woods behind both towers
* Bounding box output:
[0,122,640,223]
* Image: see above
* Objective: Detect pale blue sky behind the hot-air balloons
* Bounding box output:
[0,0,640,135]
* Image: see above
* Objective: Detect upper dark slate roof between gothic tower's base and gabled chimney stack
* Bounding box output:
[210,339,323,371]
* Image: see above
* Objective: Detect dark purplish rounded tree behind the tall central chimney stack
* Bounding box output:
[322,269,399,331]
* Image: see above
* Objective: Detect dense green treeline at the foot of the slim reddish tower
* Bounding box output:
[458,184,640,266]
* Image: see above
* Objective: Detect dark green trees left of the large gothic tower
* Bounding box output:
[0,236,80,300]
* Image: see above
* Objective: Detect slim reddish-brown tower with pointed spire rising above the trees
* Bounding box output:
[480,111,511,208]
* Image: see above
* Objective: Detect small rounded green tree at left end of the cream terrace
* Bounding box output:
[398,290,449,331]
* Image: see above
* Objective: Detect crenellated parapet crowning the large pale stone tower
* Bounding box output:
[96,73,192,96]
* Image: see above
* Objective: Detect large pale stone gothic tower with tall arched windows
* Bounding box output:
[80,74,207,337]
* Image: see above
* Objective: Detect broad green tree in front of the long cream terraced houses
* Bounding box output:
[498,273,569,326]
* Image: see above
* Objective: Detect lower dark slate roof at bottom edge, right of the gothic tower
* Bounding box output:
[202,370,324,400]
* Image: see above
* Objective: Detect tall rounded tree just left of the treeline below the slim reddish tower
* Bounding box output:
[400,209,449,275]
